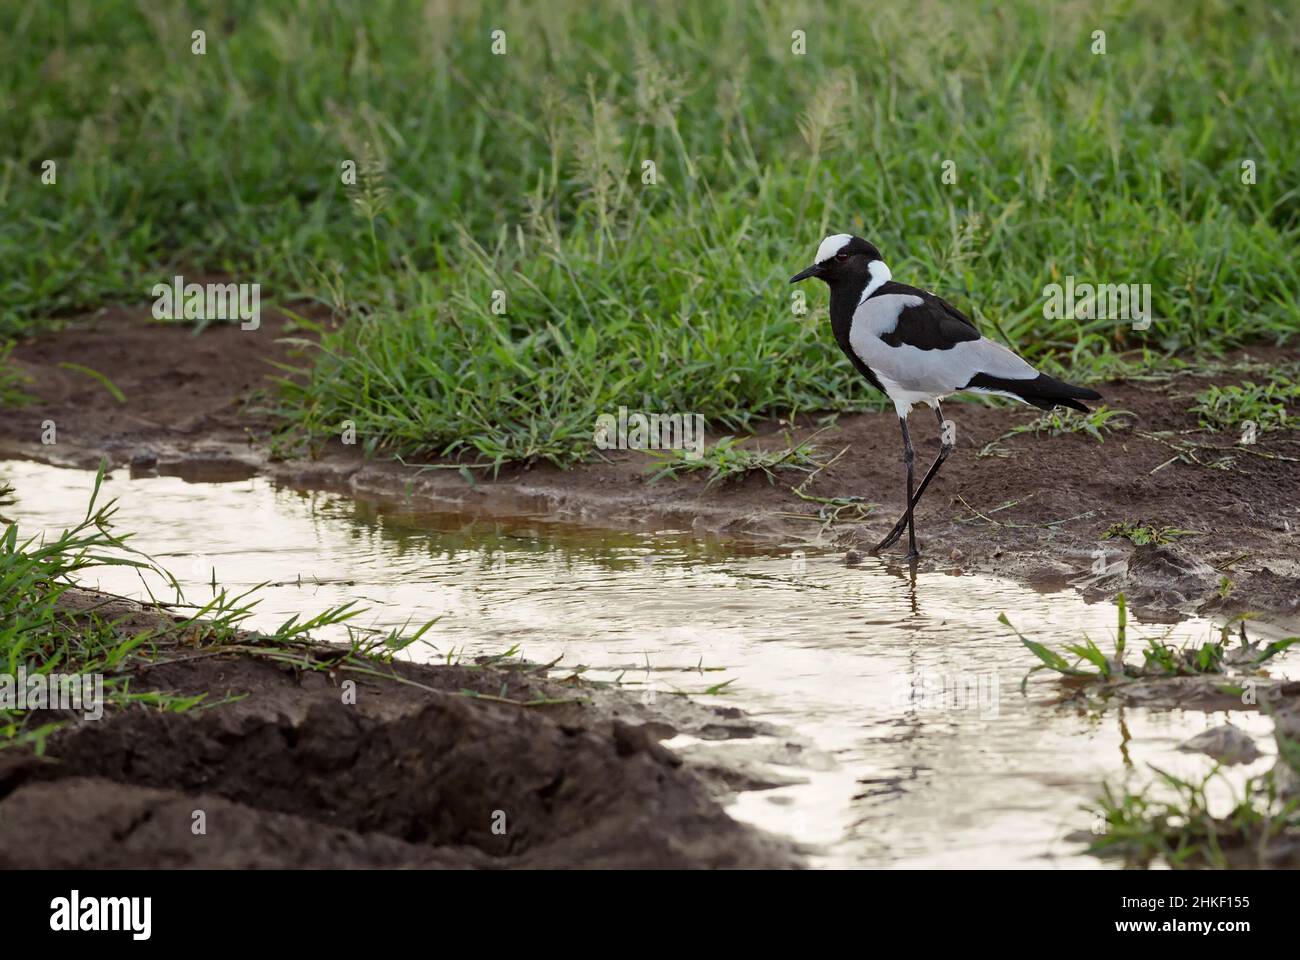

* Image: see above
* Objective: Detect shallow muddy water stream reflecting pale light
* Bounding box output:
[0,463,1300,868]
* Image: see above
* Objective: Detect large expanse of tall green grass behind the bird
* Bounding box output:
[0,0,1300,464]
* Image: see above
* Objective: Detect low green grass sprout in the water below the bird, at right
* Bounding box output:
[997,593,1300,692]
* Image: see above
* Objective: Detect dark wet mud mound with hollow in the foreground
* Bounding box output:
[0,582,801,869]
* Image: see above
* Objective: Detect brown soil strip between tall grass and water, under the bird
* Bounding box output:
[0,310,1300,615]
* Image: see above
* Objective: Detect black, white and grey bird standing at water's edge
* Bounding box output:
[790,233,1101,559]
